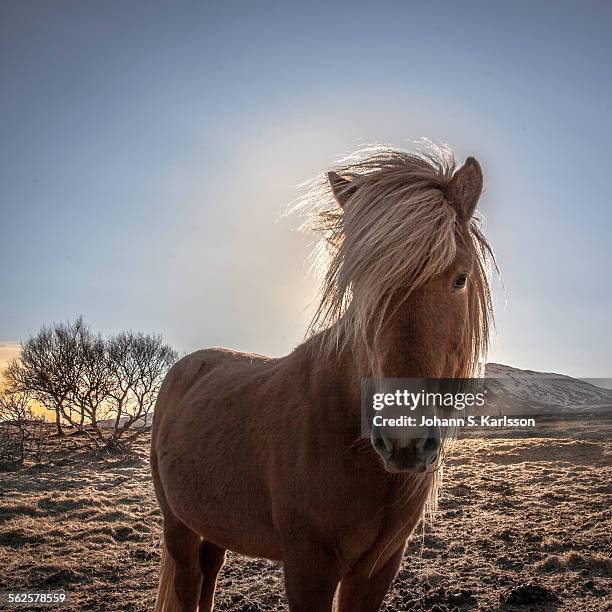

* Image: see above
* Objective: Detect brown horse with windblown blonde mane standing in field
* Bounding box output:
[151,147,498,612]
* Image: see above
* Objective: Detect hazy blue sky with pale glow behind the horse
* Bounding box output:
[0,0,612,377]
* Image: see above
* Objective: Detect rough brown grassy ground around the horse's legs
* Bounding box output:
[0,432,612,612]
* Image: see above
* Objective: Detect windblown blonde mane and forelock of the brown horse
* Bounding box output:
[292,144,494,377]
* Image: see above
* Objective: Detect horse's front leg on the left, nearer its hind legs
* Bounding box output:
[284,542,340,612]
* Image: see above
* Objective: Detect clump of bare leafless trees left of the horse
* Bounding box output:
[6,317,178,448]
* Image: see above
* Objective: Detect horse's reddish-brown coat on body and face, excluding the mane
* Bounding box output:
[151,146,494,612]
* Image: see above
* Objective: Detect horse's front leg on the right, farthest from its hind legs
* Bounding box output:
[338,545,404,612]
